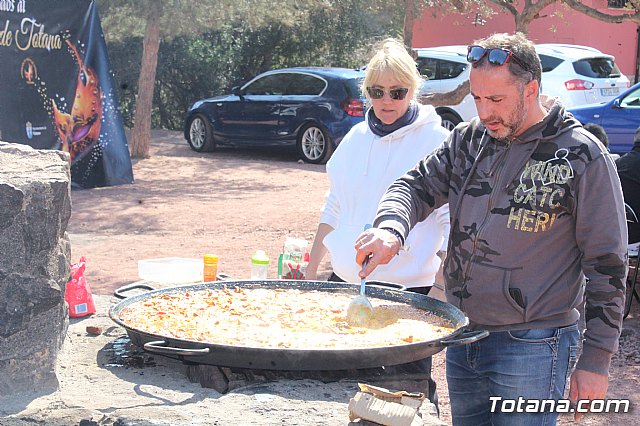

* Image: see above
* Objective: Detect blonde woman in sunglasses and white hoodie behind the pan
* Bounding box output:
[307,39,449,407]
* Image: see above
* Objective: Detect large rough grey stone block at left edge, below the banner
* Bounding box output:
[0,142,71,395]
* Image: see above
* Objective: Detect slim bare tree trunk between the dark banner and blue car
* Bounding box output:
[130,1,162,158]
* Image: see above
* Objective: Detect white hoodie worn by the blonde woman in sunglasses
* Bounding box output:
[320,105,449,288]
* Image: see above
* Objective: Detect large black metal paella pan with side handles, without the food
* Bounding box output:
[109,280,488,370]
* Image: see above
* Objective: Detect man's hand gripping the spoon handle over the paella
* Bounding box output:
[354,228,402,278]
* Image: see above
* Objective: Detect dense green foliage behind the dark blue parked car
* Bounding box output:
[105,0,402,130]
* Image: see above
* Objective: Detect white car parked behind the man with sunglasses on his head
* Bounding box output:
[415,44,630,129]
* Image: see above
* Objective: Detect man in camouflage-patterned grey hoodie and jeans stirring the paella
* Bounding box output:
[355,34,627,426]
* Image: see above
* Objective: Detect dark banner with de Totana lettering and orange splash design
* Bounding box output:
[0,0,133,188]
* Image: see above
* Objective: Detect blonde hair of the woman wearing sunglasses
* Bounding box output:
[362,38,423,99]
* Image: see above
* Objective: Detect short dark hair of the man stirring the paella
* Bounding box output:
[473,32,542,86]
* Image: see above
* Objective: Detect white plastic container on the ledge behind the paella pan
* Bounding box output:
[138,257,204,284]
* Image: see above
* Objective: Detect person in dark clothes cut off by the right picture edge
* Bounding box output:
[616,127,640,243]
